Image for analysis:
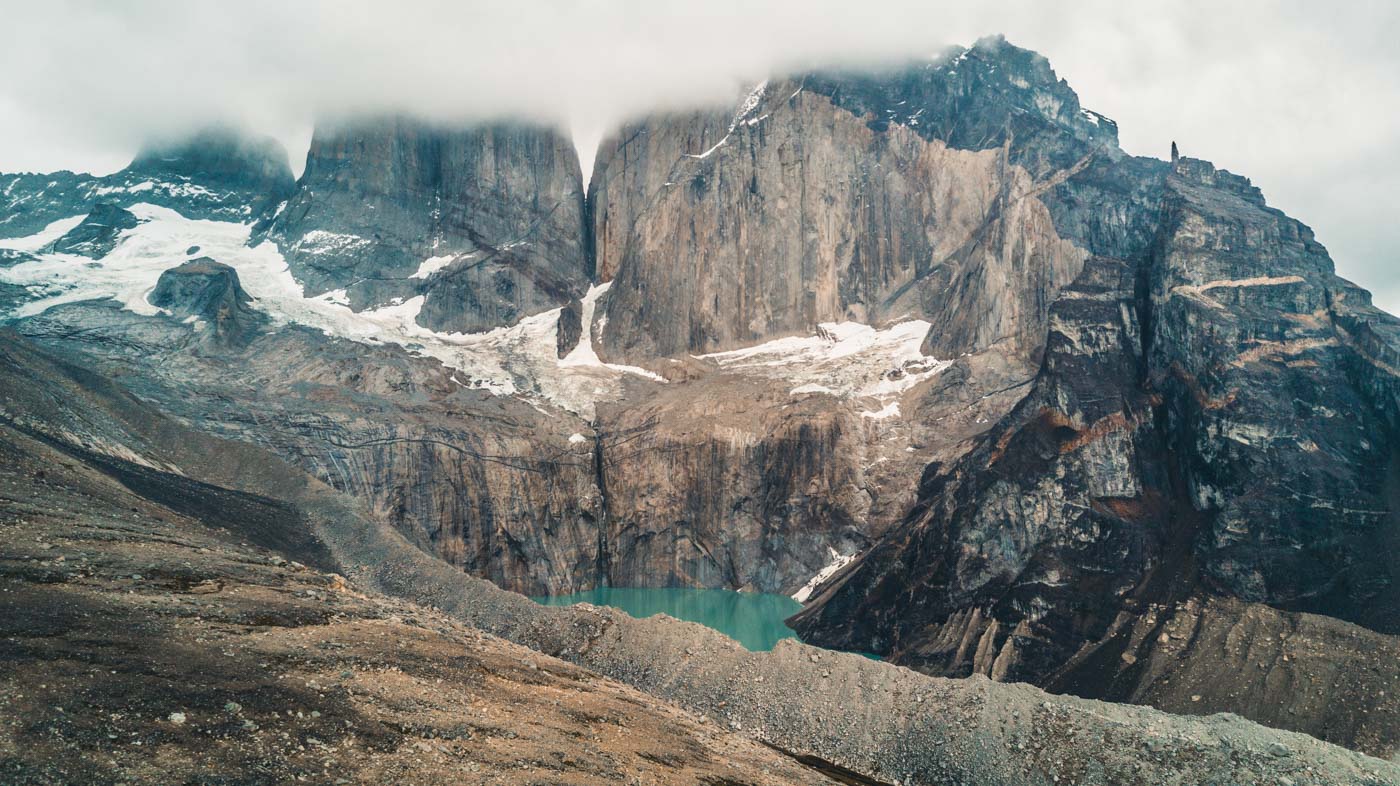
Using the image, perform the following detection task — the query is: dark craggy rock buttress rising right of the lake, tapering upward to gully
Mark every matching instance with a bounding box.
[795,258,1179,680]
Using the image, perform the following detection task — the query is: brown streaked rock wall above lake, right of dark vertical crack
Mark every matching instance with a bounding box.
[599,378,878,594]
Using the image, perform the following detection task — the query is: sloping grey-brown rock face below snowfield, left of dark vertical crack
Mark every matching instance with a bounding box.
[18,299,607,594]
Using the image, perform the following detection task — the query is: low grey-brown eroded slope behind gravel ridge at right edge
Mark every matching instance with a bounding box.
[1046,597,1400,758]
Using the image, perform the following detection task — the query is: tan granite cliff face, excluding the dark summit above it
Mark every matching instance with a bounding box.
[598,81,1084,360]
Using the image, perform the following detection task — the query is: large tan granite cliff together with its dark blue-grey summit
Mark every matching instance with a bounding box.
[591,39,1170,360]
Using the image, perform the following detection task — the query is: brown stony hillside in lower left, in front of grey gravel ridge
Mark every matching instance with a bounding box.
[0,389,836,786]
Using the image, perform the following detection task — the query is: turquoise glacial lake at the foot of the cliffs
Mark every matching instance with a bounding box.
[535,587,802,651]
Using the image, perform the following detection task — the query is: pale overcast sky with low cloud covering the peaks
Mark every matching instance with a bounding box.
[0,0,1400,312]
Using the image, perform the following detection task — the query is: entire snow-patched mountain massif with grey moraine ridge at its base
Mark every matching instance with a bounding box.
[0,30,1400,783]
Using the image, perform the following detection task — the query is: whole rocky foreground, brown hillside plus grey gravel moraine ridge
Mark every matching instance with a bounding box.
[0,335,1400,785]
